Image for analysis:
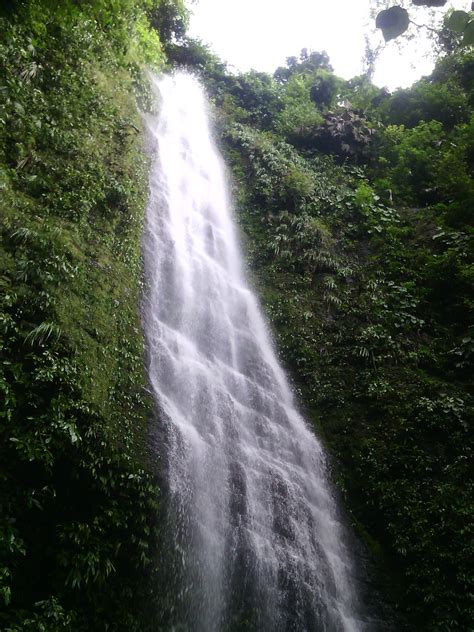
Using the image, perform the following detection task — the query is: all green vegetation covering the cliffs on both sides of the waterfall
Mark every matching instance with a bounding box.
[0,0,474,632]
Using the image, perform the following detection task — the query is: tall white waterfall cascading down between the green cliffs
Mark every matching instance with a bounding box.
[144,74,364,632]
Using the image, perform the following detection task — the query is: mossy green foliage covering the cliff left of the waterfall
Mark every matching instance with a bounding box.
[0,0,184,632]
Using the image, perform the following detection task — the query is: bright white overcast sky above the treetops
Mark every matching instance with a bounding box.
[188,0,471,89]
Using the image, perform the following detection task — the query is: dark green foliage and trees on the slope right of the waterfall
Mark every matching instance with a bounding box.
[172,42,474,630]
